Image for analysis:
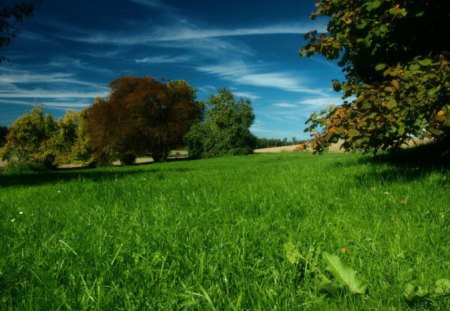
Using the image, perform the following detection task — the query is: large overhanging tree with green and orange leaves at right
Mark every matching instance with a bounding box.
[300,0,450,152]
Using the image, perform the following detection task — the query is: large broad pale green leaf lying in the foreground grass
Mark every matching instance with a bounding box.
[323,252,367,294]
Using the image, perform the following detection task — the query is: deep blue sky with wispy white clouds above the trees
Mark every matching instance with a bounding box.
[0,0,342,138]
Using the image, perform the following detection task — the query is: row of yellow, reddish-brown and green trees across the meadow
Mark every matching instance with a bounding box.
[0,76,257,169]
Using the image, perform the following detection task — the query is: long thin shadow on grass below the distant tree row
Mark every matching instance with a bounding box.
[0,163,191,188]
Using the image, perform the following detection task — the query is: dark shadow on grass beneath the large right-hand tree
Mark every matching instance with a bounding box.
[357,144,450,184]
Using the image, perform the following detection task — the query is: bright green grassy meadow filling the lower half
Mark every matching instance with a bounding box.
[0,154,450,310]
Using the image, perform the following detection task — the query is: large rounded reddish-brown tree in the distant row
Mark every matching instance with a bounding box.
[87,76,201,164]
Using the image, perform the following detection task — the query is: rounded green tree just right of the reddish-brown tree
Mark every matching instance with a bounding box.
[185,89,256,158]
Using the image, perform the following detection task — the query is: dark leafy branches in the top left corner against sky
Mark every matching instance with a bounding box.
[0,0,35,62]
